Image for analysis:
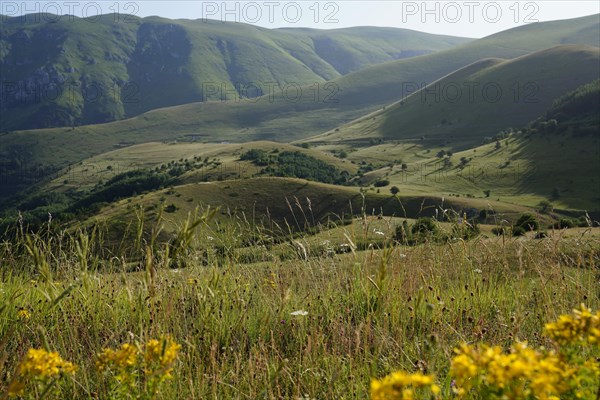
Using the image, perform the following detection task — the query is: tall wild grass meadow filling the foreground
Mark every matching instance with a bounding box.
[0,209,600,399]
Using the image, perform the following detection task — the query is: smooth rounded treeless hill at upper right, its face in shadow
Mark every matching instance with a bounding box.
[315,45,600,147]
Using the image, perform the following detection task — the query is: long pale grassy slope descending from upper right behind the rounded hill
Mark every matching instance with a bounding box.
[2,16,600,174]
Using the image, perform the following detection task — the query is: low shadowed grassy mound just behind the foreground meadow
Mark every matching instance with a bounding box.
[90,178,529,238]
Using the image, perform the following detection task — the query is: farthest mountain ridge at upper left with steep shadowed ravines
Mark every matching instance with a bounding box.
[0,14,469,131]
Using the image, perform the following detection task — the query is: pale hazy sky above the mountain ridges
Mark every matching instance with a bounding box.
[0,0,600,38]
